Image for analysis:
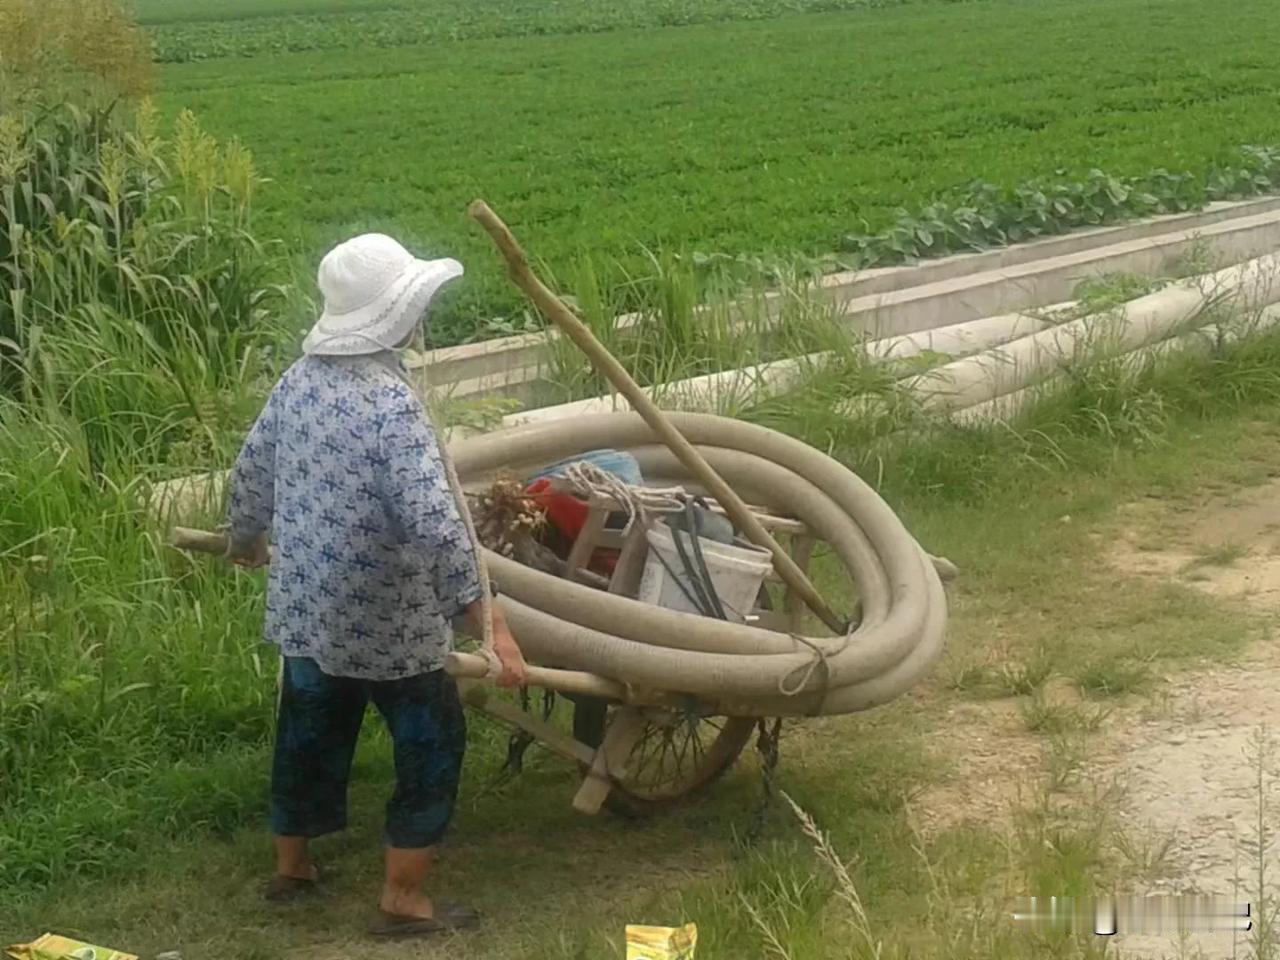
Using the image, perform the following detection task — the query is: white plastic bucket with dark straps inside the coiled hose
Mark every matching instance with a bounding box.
[637,525,773,623]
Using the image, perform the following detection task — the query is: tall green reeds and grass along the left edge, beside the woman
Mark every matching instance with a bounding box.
[0,101,293,887]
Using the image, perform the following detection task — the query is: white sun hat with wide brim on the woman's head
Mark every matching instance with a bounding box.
[302,233,462,356]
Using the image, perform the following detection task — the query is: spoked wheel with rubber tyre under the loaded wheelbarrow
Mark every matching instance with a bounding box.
[573,699,756,818]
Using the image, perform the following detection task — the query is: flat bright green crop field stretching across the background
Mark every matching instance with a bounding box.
[152,0,1280,339]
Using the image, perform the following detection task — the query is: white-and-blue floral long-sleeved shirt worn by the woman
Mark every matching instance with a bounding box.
[229,355,481,680]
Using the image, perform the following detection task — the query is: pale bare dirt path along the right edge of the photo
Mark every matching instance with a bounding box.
[1107,481,1280,957]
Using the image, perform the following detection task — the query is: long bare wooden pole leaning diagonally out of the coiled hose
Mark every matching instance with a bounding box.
[467,200,849,634]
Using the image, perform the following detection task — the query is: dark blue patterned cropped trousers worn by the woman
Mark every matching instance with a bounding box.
[271,657,467,849]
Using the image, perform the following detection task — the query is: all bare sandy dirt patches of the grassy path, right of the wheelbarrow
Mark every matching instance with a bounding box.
[922,480,1280,960]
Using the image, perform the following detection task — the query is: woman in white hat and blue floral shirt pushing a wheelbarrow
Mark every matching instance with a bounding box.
[229,234,525,936]
